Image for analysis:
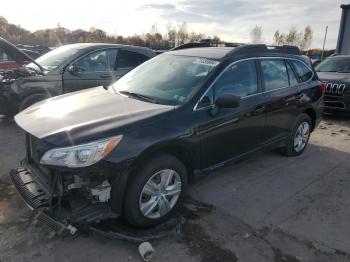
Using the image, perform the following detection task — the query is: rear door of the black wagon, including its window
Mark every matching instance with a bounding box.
[260,58,300,144]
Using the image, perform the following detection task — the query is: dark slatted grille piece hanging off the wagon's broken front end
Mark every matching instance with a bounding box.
[10,168,49,209]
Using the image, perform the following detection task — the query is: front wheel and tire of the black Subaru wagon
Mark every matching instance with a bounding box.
[123,154,188,228]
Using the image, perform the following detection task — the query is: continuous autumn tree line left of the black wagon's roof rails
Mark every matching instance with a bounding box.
[0,17,220,49]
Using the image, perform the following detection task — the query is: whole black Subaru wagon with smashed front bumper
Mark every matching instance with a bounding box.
[11,45,324,231]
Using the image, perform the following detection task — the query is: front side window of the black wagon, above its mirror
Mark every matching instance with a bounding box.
[213,60,258,97]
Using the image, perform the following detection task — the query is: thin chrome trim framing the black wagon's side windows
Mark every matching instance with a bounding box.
[193,56,315,111]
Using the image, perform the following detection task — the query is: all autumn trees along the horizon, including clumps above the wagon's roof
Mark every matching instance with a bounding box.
[0,16,313,50]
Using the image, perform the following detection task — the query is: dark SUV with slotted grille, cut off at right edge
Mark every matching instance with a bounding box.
[316,55,350,112]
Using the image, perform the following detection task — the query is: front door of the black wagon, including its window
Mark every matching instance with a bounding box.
[195,59,265,168]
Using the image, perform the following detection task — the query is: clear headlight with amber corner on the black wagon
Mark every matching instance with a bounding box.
[40,135,123,168]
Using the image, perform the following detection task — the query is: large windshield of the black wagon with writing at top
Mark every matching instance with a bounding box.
[112,54,219,105]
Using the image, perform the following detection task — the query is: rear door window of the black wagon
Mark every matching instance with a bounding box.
[260,59,289,91]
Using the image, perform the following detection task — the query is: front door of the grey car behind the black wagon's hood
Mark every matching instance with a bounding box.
[63,48,118,93]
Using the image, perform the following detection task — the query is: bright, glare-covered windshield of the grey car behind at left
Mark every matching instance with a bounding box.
[27,45,79,72]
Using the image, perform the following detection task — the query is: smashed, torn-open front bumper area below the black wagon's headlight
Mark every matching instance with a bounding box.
[10,165,118,234]
